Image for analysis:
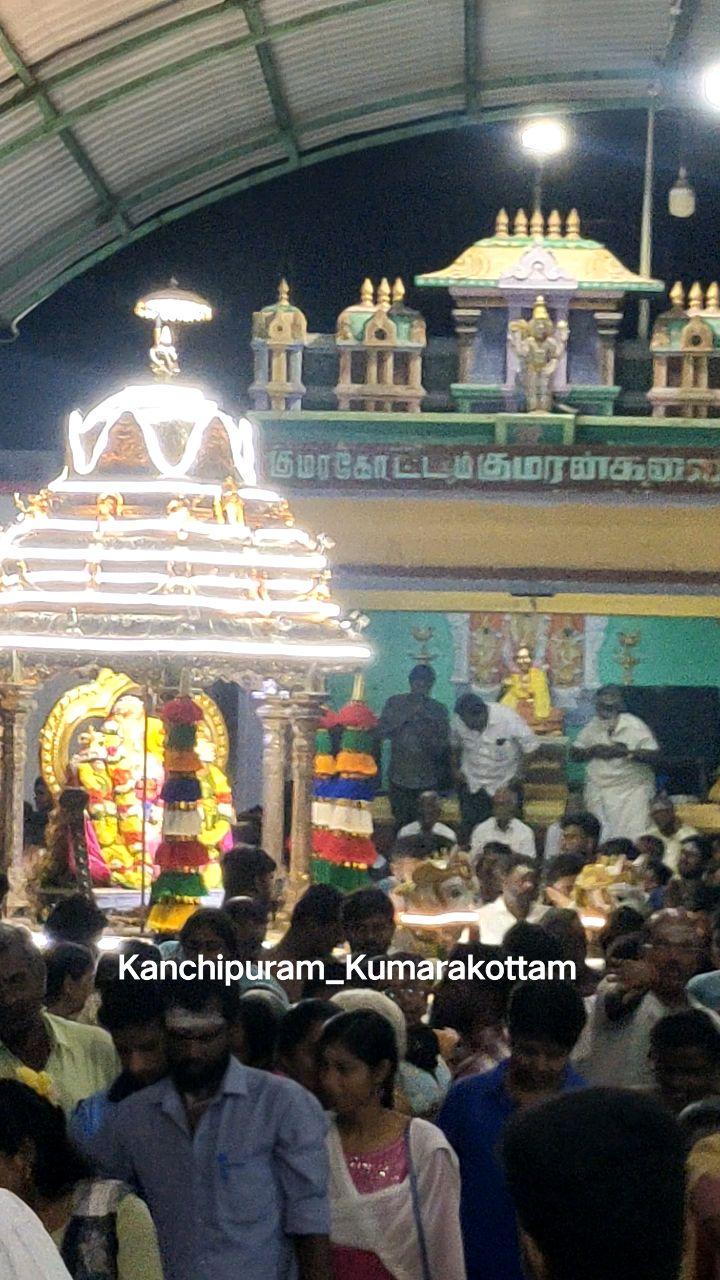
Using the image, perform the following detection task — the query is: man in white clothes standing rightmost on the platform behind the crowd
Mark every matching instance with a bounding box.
[570,685,660,841]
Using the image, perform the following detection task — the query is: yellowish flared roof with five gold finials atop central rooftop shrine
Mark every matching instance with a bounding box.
[415,209,665,296]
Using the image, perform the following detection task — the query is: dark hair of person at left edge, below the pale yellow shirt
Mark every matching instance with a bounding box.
[0,1080,90,1199]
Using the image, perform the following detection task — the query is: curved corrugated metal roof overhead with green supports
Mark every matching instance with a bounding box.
[0,0,707,323]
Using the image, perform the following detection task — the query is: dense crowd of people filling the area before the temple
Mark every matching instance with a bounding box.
[0,668,720,1280]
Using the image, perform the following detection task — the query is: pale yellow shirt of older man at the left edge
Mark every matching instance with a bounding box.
[0,1010,120,1115]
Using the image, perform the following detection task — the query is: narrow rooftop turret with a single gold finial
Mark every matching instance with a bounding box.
[250,279,307,413]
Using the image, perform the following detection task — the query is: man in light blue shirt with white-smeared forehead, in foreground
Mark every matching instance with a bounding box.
[95,982,331,1280]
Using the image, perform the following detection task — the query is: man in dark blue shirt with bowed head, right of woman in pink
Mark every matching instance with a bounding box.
[438,982,585,1280]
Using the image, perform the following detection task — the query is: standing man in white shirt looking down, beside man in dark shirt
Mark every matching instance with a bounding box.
[450,694,541,845]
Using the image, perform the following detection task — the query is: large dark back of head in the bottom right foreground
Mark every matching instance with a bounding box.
[502,1089,685,1280]
